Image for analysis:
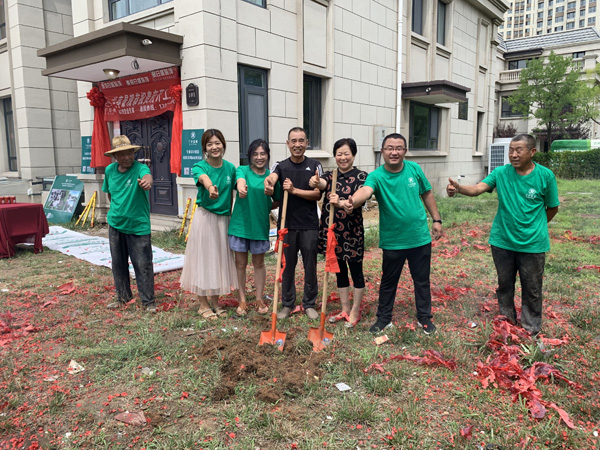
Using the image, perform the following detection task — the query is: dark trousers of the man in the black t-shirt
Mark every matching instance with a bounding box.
[281,230,319,309]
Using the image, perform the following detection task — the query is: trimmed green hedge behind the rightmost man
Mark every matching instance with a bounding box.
[533,149,600,179]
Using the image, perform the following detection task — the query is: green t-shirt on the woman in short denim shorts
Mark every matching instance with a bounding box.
[229,166,279,241]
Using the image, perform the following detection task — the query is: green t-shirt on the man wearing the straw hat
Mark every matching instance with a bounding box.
[102,161,150,236]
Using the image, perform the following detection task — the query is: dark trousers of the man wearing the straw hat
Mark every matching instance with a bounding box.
[108,226,154,306]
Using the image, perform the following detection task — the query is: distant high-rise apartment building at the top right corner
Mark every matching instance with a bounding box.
[499,0,600,41]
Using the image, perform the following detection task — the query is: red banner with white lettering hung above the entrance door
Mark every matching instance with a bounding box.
[98,66,180,121]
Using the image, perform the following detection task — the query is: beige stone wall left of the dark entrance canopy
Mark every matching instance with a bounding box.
[0,0,81,181]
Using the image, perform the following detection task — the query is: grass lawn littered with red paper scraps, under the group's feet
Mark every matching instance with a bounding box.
[0,180,600,449]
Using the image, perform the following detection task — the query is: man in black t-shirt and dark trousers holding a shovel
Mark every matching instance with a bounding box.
[265,127,323,320]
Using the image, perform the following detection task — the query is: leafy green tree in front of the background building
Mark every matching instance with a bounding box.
[508,52,598,147]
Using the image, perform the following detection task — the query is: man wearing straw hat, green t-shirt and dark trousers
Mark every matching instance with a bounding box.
[102,136,156,313]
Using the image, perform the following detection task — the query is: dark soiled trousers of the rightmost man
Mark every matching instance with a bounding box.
[492,245,546,334]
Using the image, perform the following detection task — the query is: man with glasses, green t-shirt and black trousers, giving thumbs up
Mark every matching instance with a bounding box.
[344,133,442,334]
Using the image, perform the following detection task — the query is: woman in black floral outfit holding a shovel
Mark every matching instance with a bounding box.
[309,138,367,328]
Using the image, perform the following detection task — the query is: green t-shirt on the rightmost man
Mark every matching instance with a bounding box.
[483,164,560,253]
